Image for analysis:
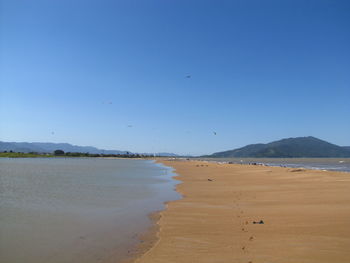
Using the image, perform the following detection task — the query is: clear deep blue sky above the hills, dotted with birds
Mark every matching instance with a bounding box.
[0,0,350,154]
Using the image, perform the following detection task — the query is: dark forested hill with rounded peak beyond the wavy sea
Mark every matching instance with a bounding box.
[207,136,350,158]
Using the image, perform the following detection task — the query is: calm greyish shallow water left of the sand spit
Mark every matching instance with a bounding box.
[0,158,179,263]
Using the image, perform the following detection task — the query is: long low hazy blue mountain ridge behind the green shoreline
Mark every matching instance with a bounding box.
[0,141,127,154]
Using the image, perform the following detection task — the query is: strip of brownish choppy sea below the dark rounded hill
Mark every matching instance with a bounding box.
[197,158,350,172]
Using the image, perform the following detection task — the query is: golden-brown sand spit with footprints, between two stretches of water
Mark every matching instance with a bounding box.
[136,161,350,263]
